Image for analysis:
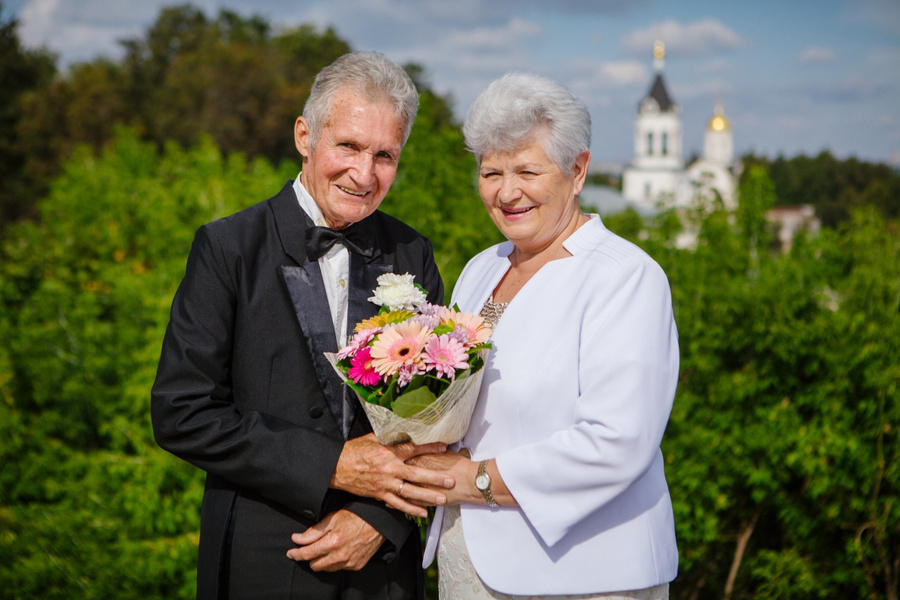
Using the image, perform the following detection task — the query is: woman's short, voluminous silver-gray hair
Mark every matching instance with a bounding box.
[463,73,591,174]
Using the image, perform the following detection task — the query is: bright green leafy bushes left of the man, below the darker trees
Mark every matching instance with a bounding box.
[0,131,293,598]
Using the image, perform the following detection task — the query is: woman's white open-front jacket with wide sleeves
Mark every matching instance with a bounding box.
[425,215,679,595]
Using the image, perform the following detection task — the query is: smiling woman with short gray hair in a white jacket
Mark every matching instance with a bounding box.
[414,74,678,600]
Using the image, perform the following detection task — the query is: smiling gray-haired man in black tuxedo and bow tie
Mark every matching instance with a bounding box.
[152,52,454,599]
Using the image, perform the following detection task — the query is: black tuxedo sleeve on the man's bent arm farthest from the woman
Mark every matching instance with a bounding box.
[151,226,343,520]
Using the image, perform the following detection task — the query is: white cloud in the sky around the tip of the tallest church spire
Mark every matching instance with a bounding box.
[620,18,744,56]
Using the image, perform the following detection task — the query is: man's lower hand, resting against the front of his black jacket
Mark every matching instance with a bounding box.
[287,510,384,571]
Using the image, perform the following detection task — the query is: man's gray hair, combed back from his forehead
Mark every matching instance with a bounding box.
[303,51,419,148]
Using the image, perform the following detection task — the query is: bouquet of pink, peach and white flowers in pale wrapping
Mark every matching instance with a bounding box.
[326,273,491,444]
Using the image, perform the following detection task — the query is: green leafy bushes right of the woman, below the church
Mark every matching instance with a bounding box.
[608,168,900,600]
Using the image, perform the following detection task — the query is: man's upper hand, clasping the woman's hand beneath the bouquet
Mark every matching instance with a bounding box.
[331,433,455,517]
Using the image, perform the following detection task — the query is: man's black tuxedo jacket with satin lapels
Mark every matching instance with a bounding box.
[152,182,444,598]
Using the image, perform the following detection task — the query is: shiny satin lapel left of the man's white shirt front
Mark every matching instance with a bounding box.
[281,261,350,438]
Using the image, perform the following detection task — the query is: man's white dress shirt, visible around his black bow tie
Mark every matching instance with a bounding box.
[294,174,355,348]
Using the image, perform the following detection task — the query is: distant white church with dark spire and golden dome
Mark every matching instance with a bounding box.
[622,41,740,211]
